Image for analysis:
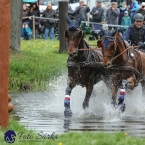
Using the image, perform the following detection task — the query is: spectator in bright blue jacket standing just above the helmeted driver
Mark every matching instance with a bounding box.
[129,0,139,23]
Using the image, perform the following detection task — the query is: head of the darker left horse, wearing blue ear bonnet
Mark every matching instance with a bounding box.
[65,16,83,56]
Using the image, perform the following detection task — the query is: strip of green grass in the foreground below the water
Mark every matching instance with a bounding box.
[0,119,145,145]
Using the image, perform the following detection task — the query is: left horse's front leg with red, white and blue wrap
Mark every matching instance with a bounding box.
[64,78,75,117]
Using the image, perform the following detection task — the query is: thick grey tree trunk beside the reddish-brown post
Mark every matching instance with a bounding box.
[10,0,23,51]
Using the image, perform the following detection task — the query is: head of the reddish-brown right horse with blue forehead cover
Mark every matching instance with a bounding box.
[97,29,117,67]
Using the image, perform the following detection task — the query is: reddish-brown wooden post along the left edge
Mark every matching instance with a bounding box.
[0,0,10,127]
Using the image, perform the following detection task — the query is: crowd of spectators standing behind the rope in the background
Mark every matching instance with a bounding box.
[22,0,145,40]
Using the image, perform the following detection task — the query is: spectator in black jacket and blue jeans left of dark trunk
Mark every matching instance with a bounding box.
[42,4,56,40]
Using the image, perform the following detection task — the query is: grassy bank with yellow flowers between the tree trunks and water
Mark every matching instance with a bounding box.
[9,39,68,93]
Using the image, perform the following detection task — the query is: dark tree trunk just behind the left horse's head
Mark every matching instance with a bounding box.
[59,1,68,53]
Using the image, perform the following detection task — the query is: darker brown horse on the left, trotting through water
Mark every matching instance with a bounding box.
[64,17,109,117]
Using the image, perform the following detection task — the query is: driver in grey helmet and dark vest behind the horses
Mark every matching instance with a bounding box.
[123,13,145,52]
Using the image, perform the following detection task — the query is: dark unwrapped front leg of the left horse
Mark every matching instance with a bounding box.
[83,84,93,109]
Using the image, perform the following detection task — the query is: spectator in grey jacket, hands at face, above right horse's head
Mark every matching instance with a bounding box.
[106,2,120,30]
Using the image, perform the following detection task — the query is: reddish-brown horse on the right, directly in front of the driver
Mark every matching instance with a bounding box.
[97,33,145,110]
